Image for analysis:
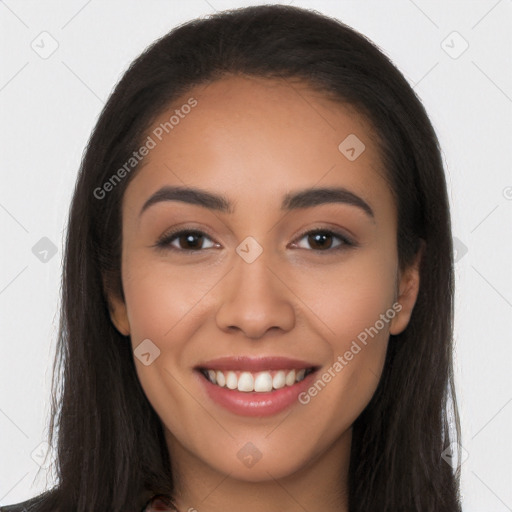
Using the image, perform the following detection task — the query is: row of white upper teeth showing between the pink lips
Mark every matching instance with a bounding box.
[205,368,306,393]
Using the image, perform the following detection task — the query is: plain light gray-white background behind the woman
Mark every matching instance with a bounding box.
[0,0,512,512]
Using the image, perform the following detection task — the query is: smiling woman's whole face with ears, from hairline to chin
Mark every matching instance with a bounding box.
[107,77,418,481]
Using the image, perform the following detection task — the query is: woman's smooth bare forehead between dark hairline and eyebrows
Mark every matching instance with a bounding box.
[125,76,392,220]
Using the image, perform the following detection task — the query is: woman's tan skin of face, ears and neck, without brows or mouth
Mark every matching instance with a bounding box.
[110,76,419,512]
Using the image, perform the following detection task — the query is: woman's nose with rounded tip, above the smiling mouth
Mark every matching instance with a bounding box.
[216,251,295,339]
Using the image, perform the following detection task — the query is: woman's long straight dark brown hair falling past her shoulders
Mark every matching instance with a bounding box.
[36,5,460,512]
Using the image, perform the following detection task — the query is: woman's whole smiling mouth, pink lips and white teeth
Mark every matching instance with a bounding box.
[194,357,320,417]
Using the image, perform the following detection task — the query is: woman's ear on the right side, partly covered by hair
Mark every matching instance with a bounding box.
[389,240,426,334]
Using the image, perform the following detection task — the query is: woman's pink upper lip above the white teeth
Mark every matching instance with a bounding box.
[196,356,317,372]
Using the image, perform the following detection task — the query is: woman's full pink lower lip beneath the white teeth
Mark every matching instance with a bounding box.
[197,372,316,416]
